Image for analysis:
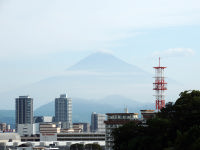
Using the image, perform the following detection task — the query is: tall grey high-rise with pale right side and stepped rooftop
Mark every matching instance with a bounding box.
[55,94,73,129]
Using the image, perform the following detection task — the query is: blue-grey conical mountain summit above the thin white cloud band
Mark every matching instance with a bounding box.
[67,51,143,72]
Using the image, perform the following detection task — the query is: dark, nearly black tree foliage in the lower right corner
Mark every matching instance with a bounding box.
[113,90,200,150]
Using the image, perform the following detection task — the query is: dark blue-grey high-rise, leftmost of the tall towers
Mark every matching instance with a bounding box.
[15,96,33,129]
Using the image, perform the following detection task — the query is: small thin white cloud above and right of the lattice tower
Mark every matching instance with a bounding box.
[153,48,195,58]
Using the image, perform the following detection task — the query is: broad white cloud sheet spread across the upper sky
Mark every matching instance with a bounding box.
[0,0,200,58]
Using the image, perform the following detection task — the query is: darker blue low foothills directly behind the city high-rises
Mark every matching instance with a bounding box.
[34,95,154,122]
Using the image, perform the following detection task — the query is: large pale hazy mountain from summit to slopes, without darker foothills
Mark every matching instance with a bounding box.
[0,52,177,109]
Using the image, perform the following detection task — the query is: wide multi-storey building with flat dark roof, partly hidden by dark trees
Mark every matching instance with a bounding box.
[105,113,138,150]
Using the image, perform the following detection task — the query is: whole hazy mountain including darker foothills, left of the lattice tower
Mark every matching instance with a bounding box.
[0,52,181,123]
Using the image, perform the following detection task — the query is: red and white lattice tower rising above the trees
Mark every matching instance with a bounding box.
[153,57,167,111]
